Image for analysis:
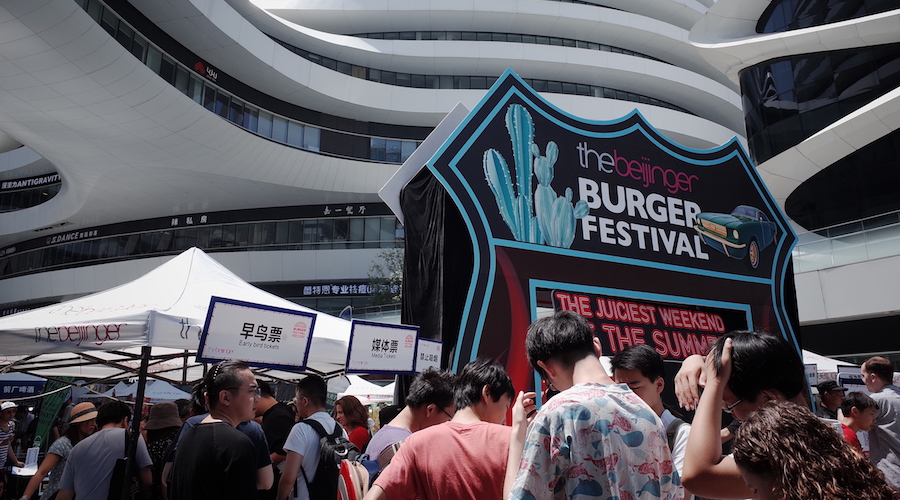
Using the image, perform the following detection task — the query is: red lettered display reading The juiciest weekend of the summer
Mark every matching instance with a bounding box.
[552,290,750,360]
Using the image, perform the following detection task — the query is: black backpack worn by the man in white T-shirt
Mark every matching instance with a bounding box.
[300,419,360,500]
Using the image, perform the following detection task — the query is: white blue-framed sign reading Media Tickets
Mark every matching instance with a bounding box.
[345,319,419,374]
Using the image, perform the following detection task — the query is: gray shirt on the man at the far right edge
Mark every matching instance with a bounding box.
[869,385,900,490]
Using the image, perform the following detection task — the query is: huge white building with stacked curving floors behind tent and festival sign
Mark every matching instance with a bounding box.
[0,0,743,322]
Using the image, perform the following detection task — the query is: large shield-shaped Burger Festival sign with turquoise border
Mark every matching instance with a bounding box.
[400,70,799,392]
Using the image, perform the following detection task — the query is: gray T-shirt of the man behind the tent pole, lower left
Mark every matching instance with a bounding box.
[59,427,153,500]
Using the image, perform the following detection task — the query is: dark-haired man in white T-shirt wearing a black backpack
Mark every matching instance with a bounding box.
[276,375,350,500]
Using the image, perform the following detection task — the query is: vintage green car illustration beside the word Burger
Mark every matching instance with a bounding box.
[694,205,778,269]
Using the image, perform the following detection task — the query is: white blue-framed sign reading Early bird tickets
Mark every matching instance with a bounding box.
[197,297,316,370]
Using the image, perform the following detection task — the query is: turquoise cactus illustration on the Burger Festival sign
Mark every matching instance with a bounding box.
[483,104,588,248]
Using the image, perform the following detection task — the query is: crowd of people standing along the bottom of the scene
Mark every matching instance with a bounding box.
[0,311,900,500]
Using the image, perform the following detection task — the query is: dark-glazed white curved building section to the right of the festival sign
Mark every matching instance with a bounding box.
[690,0,900,362]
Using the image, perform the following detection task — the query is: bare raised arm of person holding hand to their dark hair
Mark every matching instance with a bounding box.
[679,339,753,498]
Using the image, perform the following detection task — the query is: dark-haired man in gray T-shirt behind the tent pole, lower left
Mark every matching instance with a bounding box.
[56,401,153,500]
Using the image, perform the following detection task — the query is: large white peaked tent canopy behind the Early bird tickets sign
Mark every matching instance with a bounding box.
[0,248,350,383]
